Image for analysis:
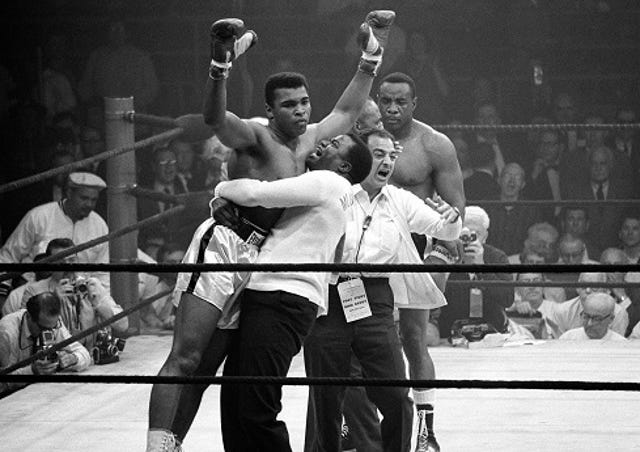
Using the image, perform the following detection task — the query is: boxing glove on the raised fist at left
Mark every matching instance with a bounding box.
[209,19,258,80]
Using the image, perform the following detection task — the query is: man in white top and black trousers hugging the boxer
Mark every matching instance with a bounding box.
[216,134,371,451]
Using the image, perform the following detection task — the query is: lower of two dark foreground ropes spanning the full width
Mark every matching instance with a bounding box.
[0,374,640,392]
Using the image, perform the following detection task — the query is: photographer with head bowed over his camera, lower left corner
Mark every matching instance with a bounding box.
[0,292,91,396]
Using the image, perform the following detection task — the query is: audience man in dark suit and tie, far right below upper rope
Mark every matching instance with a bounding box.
[567,146,633,256]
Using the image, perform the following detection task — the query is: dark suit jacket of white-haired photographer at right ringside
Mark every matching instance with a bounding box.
[439,244,513,338]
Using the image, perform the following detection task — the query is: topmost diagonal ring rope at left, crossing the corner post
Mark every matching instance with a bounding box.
[0,127,184,194]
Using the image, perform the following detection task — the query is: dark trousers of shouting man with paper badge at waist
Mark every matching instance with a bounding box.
[304,278,413,452]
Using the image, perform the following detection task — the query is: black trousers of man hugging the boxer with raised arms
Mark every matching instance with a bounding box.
[220,289,318,452]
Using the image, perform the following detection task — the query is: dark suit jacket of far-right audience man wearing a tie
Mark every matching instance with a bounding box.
[567,177,632,254]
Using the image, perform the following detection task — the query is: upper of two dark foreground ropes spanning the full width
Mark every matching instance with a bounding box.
[0,260,640,274]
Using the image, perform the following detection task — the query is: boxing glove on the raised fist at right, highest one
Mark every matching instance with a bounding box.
[356,10,396,76]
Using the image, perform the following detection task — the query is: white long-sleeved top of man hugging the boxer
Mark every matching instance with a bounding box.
[216,170,353,315]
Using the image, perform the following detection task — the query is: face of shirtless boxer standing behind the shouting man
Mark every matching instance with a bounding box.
[378,82,416,133]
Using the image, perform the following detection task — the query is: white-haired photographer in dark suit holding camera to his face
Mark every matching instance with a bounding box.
[439,206,513,338]
